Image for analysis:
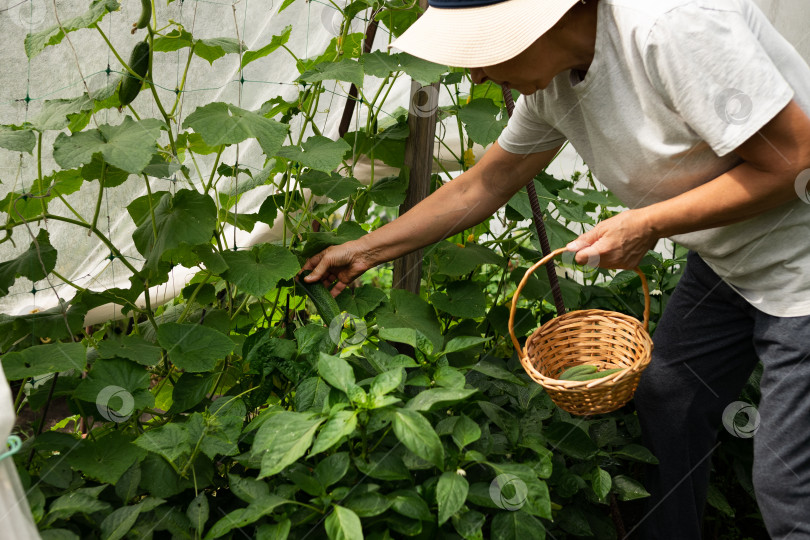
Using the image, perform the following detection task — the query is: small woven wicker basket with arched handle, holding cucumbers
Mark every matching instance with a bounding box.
[509,248,653,415]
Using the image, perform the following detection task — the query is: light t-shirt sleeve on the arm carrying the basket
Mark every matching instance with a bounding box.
[642,2,794,157]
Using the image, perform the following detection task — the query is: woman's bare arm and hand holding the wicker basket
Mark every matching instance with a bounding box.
[568,101,810,268]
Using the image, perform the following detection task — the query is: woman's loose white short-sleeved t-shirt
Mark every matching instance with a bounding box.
[498,0,810,316]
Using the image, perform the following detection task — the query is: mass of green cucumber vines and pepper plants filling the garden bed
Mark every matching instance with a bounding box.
[0,0,756,540]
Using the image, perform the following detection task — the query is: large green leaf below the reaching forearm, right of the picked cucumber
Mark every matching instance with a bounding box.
[376,289,443,351]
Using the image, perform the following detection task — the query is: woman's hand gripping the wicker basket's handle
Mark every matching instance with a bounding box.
[566,209,658,269]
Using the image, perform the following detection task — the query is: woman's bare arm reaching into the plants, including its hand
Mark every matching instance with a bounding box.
[302,142,559,296]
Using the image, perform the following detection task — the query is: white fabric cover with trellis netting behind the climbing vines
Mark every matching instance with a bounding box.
[0,0,810,325]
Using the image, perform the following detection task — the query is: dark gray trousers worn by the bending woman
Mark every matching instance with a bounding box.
[633,252,810,540]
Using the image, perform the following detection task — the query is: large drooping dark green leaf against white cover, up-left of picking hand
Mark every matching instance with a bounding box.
[127,189,217,269]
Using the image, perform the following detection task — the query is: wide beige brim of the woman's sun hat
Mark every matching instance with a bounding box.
[390,0,580,67]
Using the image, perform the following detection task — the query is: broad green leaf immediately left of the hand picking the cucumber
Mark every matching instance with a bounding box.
[222,244,301,298]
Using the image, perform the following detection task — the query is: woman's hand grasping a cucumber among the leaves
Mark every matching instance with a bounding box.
[299,240,375,296]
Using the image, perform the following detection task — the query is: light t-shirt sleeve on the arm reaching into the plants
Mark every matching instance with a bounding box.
[498,94,567,154]
